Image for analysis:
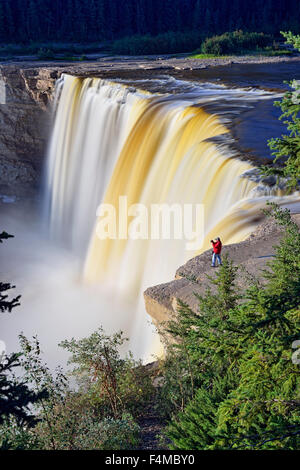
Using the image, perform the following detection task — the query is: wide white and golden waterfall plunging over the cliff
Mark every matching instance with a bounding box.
[46,75,298,359]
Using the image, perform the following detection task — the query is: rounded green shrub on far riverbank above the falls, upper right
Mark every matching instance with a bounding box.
[201,31,272,55]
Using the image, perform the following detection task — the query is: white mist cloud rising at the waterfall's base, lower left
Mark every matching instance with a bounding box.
[0,205,161,369]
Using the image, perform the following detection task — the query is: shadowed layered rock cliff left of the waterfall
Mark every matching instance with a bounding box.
[0,66,58,197]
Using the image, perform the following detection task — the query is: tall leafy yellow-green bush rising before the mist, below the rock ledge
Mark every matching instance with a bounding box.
[60,328,154,419]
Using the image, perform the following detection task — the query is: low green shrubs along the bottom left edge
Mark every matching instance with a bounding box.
[0,395,140,450]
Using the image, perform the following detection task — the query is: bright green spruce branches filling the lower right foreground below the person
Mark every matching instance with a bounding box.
[165,206,300,449]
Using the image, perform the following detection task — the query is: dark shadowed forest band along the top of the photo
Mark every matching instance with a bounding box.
[0,0,300,43]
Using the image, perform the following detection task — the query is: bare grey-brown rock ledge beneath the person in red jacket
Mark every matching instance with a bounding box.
[144,214,300,326]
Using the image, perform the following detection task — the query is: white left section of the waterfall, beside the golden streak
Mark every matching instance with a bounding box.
[46,75,148,252]
